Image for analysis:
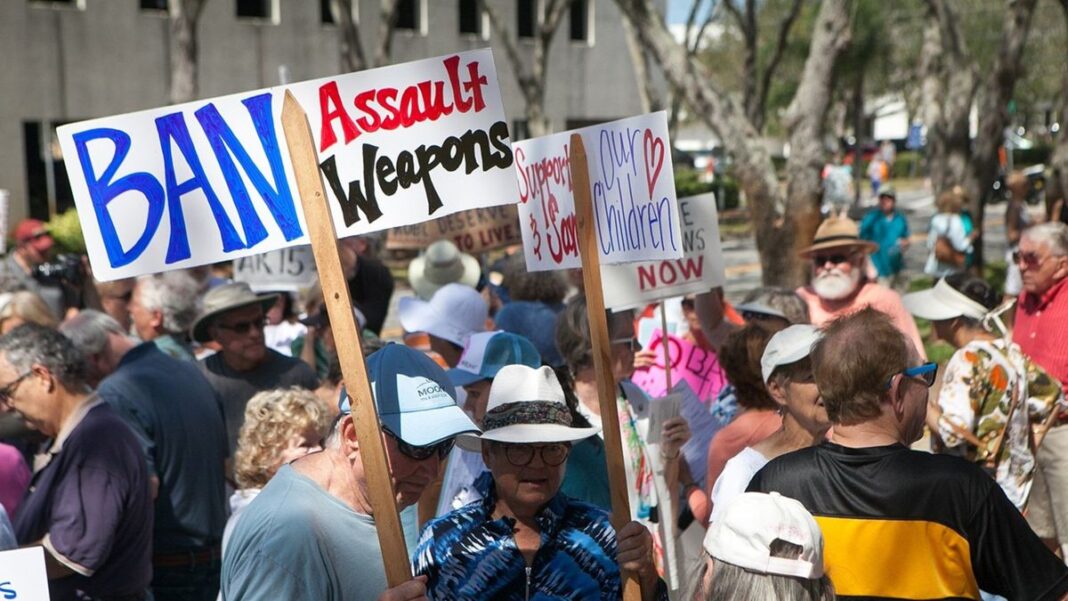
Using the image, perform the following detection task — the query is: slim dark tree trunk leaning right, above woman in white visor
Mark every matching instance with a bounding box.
[963,0,1037,266]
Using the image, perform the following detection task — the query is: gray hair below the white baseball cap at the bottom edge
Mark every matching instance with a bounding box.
[694,557,835,601]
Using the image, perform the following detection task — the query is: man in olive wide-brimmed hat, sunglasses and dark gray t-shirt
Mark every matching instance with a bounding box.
[192,282,319,455]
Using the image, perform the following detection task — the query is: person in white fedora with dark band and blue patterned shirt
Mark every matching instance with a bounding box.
[414,365,668,600]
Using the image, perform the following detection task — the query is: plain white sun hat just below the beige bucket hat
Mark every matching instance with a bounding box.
[397,284,489,346]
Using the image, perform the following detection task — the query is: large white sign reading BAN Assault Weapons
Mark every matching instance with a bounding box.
[59,49,516,281]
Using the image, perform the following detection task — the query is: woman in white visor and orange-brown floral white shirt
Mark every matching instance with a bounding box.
[902,273,1064,510]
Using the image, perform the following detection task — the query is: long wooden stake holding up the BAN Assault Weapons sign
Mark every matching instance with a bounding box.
[282,91,411,588]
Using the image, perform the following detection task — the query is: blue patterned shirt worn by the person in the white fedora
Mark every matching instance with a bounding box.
[413,472,663,601]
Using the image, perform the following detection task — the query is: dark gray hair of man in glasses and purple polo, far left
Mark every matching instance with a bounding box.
[0,318,88,392]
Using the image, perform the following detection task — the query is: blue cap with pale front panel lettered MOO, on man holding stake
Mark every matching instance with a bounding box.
[337,344,480,446]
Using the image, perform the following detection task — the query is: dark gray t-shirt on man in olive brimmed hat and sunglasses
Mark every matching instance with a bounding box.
[198,349,319,457]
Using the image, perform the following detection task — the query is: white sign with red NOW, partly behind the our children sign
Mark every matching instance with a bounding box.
[601,194,725,310]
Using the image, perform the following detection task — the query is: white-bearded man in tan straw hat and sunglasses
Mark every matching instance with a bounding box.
[797,217,924,354]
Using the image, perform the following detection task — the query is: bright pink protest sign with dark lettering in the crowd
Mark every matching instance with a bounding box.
[630,331,726,404]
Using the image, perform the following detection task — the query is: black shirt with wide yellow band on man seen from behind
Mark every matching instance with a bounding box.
[749,443,1068,601]
